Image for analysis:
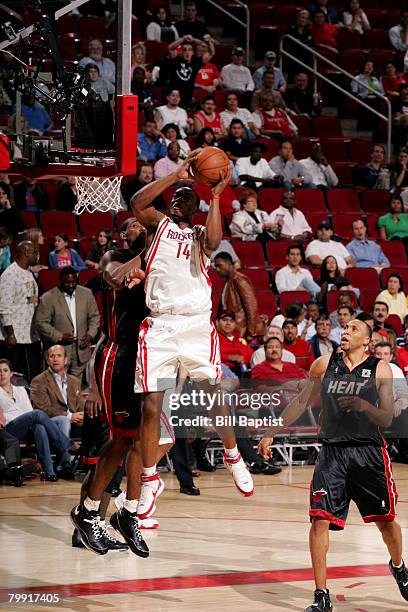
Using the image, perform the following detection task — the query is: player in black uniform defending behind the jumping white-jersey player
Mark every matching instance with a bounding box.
[71,217,171,557]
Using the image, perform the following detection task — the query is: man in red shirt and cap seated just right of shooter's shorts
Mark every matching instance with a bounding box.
[217,311,253,376]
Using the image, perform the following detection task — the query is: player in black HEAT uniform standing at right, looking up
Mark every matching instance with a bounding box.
[259,320,408,612]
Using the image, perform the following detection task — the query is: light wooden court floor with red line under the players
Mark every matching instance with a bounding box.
[0,465,408,612]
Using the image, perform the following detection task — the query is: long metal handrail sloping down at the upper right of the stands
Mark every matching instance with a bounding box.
[279,34,392,163]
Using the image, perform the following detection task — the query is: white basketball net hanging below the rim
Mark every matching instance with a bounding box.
[74,176,123,215]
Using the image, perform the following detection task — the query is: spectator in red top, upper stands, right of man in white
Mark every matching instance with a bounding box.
[252,94,298,142]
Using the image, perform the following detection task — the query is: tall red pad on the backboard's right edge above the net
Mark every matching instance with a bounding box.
[115,95,138,175]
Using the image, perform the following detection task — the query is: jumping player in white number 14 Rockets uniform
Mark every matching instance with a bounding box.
[131,150,253,518]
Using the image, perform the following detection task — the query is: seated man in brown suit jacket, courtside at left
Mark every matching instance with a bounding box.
[30,344,84,438]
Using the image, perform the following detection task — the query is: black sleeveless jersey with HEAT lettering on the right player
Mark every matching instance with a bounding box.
[320,353,384,445]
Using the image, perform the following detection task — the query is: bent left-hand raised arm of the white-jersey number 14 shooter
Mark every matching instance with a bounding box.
[130,149,201,230]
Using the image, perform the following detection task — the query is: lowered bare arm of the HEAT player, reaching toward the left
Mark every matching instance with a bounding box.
[258,355,330,459]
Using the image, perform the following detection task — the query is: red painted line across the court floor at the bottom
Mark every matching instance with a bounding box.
[0,565,390,603]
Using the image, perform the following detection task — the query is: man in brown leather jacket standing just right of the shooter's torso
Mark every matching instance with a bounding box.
[214,253,265,340]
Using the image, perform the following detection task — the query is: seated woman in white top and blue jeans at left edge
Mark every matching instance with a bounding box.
[0,359,74,482]
